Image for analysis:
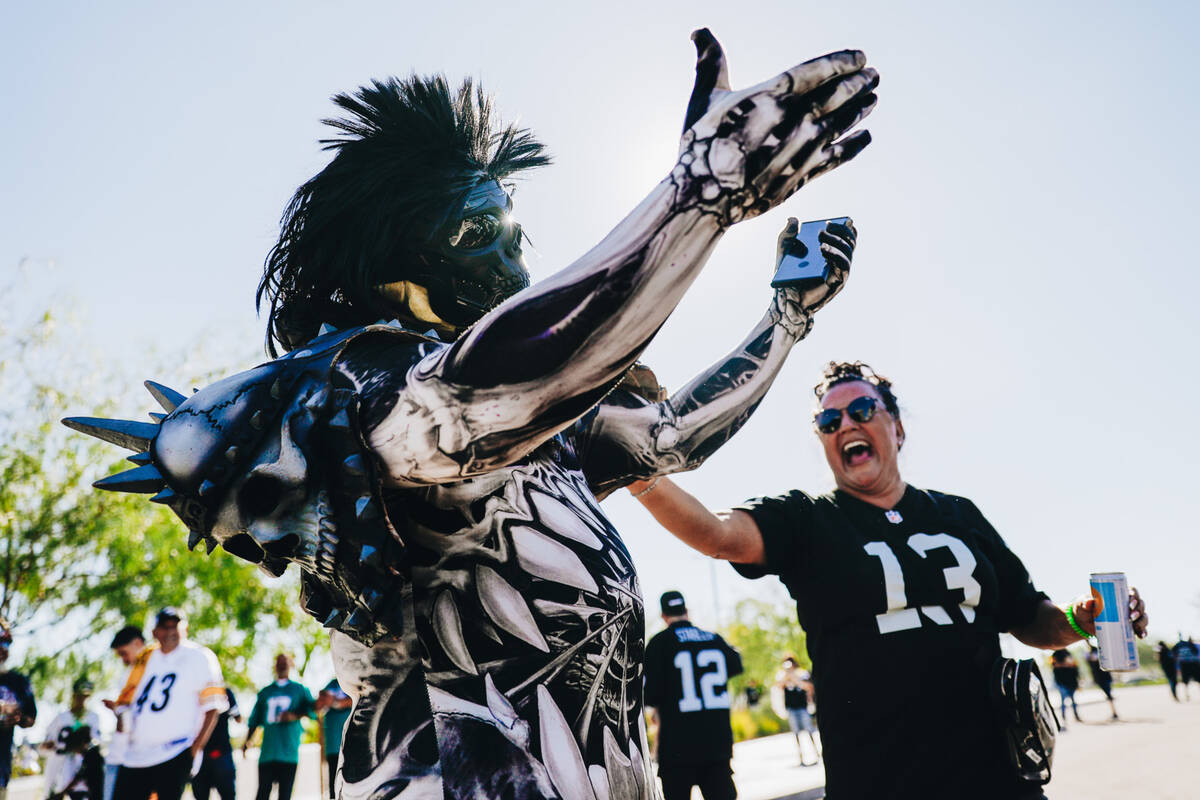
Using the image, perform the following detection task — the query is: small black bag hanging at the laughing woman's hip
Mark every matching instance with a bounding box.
[990,658,1062,786]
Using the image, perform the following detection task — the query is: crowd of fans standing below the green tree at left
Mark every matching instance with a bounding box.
[0,607,352,800]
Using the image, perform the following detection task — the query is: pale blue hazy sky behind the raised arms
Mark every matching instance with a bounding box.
[0,2,1200,690]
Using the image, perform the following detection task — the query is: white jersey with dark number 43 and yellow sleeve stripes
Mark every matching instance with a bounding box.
[122,642,228,768]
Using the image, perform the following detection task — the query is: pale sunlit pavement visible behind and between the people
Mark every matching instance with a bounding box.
[8,685,1200,800]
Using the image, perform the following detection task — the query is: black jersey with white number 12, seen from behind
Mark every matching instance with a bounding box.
[646,621,742,766]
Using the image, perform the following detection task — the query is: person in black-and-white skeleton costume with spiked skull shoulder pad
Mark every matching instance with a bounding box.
[67,30,878,800]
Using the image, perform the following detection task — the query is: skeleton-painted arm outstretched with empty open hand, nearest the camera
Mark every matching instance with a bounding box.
[352,30,878,486]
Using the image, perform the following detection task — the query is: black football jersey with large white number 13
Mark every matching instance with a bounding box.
[734,486,1045,800]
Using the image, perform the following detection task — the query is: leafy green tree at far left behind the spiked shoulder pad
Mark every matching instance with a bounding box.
[0,302,328,698]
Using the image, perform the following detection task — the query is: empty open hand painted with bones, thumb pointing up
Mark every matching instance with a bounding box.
[671,29,880,225]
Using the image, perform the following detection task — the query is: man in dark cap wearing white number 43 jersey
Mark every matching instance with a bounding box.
[115,606,228,800]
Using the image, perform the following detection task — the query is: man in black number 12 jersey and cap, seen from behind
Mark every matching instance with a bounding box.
[646,591,742,800]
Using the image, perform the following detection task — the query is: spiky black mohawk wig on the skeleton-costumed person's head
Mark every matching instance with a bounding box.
[256,74,550,356]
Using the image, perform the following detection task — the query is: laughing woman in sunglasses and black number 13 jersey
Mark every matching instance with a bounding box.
[629,362,1147,800]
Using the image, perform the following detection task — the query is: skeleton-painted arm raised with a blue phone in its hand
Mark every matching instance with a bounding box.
[582,218,857,497]
